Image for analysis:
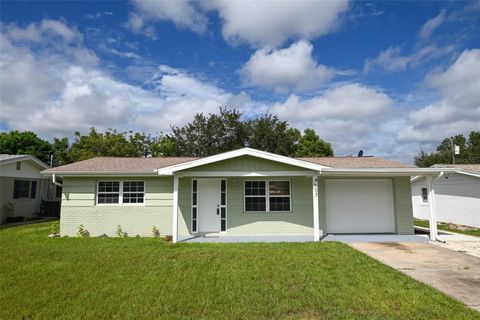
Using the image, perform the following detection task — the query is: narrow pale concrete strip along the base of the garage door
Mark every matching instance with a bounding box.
[322,234,428,243]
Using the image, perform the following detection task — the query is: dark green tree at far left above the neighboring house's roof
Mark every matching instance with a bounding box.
[0,130,52,163]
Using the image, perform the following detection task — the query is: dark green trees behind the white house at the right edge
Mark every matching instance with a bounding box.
[414,131,480,167]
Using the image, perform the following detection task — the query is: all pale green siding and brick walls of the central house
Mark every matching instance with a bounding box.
[60,160,413,237]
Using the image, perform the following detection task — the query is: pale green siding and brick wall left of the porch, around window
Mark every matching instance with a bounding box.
[60,177,173,236]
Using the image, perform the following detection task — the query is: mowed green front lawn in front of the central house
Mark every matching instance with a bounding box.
[0,223,479,319]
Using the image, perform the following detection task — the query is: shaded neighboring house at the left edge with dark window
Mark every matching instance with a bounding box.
[0,154,56,224]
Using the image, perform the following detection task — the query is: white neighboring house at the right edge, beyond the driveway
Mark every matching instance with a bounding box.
[412,164,480,228]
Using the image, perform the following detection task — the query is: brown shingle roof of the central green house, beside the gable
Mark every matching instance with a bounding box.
[43,157,409,174]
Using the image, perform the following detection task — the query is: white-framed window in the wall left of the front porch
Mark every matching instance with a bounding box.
[97,181,145,205]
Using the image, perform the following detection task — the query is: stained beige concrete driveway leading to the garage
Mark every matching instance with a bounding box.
[350,242,480,311]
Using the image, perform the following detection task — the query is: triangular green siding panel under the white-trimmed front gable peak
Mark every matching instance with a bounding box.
[188,156,314,172]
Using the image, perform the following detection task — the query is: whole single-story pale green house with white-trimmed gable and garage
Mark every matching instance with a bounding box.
[43,148,446,242]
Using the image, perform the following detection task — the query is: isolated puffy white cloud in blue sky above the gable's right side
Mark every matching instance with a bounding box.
[240,40,335,92]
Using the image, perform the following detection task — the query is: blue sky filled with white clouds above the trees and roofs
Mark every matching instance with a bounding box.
[0,0,480,162]
